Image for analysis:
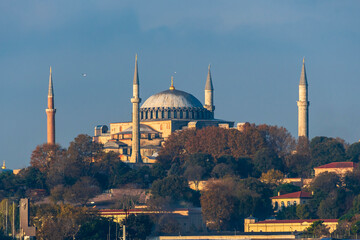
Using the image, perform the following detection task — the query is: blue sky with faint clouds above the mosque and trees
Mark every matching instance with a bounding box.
[0,0,360,168]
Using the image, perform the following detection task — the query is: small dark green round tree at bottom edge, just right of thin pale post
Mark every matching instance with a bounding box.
[122,214,154,240]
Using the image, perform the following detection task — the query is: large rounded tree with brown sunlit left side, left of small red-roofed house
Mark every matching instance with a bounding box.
[200,177,272,230]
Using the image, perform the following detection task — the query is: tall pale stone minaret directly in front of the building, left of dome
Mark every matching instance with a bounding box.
[130,55,141,163]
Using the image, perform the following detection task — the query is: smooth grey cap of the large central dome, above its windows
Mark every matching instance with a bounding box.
[141,89,203,108]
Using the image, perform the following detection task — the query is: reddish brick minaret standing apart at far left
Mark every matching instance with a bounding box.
[46,67,56,144]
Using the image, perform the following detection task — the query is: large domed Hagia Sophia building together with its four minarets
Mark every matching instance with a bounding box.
[46,56,310,163]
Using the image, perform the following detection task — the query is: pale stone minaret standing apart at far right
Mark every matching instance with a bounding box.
[297,58,310,138]
